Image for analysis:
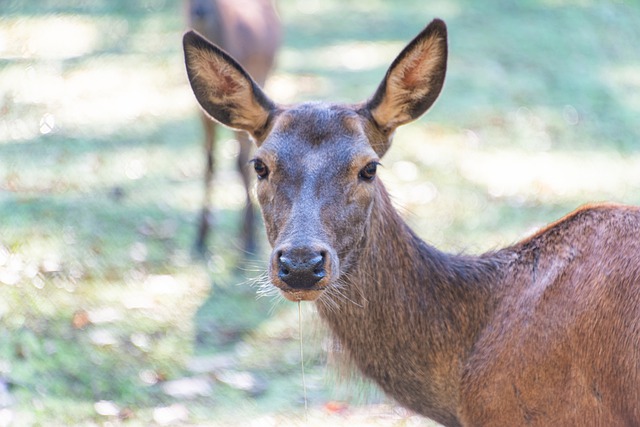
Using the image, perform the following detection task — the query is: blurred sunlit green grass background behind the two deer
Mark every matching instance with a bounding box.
[0,0,640,426]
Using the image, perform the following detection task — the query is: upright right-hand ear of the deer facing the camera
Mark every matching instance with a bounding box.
[365,19,447,133]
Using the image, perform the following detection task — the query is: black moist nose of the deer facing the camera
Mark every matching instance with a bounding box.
[278,251,326,289]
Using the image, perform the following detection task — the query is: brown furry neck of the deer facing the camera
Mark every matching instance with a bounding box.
[318,184,499,425]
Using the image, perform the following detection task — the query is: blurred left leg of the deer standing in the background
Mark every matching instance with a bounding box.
[196,114,216,254]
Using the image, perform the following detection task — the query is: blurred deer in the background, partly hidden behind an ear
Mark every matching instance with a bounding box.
[184,0,282,254]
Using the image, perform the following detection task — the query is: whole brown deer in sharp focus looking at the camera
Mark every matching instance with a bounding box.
[183,19,640,426]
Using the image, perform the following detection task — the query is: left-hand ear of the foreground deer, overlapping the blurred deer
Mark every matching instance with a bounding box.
[182,31,276,141]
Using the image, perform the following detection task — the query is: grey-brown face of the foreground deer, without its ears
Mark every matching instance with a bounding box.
[253,104,379,300]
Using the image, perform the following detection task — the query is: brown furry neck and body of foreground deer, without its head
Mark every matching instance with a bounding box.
[328,193,640,426]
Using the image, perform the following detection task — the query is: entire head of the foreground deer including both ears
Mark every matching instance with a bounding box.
[184,20,447,301]
